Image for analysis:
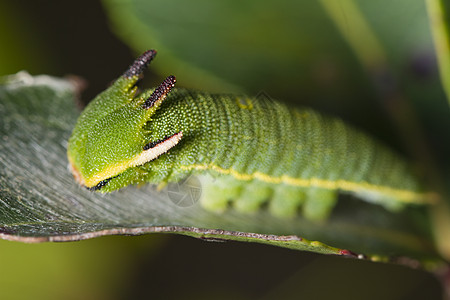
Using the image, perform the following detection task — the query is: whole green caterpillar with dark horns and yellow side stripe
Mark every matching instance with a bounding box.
[68,50,429,219]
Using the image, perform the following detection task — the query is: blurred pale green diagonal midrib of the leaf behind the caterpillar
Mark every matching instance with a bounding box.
[320,0,442,190]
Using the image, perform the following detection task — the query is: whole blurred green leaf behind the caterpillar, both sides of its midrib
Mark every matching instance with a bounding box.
[99,0,442,115]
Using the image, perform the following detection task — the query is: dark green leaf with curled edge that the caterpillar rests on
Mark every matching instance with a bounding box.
[0,73,439,267]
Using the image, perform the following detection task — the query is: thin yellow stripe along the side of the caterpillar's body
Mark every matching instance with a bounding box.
[181,164,436,204]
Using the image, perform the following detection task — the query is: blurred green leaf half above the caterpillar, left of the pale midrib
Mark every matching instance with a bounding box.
[104,0,367,107]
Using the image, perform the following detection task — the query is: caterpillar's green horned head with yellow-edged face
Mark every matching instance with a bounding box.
[67,50,183,191]
